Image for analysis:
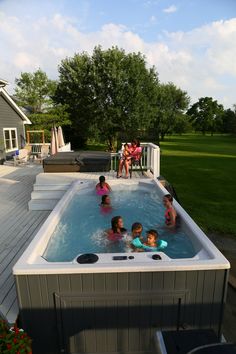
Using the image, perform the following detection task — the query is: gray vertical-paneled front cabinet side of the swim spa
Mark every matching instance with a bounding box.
[15,270,228,354]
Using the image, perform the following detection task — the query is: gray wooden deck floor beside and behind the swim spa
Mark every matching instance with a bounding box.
[0,164,148,324]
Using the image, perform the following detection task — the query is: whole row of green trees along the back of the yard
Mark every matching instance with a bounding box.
[15,46,236,150]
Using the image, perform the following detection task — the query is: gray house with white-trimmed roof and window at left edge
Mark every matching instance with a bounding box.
[0,79,32,156]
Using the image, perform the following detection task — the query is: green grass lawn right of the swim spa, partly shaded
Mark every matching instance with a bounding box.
[161,134,236,237]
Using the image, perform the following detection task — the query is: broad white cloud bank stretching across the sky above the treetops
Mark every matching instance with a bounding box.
[0,9,236,107]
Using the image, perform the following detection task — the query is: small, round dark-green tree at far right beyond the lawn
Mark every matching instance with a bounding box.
[187,97,224,134]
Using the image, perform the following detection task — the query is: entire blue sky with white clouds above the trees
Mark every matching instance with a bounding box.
[0,0,236,108]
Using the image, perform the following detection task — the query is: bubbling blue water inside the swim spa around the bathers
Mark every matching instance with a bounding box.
[43,186,196,262]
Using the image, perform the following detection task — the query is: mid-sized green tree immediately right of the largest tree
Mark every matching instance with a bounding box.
[153,82,190,142]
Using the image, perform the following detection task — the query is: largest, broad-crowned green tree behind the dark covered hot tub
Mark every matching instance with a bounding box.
[55,47,158,150]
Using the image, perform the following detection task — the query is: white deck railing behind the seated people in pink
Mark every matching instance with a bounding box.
[111,143,160,179]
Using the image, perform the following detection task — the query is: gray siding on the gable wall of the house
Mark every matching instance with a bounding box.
[0,94,25,153]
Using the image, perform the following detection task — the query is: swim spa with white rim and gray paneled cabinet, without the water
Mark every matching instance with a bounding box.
[14,180,229,353]
